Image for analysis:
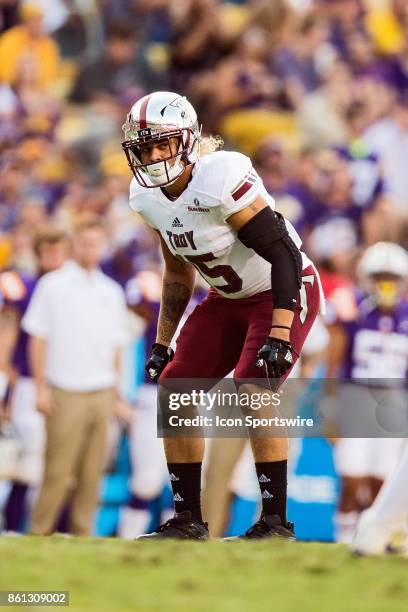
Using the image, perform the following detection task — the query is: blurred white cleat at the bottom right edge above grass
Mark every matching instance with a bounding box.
[351,509,408,555]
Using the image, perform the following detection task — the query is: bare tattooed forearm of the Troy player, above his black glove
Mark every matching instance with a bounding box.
[157,280,192,345]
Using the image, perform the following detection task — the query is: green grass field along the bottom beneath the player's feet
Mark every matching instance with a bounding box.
[0,536,408,612]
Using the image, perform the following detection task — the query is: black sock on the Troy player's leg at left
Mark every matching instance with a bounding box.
[167,462,202,521]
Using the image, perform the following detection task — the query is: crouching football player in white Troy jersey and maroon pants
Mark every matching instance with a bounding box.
[122,92,323,540]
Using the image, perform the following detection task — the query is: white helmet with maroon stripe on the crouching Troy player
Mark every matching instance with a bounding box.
[122,91,201,188]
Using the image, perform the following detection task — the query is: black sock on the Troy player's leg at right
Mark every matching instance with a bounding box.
[255,460,288,525]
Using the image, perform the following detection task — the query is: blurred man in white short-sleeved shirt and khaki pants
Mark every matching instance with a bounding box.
[22,220,127,535]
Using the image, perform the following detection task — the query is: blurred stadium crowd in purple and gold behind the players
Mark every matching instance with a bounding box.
[0,0,408,530]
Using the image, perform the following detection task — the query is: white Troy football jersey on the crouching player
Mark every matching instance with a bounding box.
[130,151,310,299]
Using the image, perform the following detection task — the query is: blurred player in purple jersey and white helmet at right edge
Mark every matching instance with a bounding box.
[335,242,408,541]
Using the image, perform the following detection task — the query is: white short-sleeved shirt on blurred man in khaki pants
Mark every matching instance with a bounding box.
[22,261,127,392]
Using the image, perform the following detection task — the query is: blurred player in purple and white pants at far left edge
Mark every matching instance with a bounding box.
[0,225,67,532]
